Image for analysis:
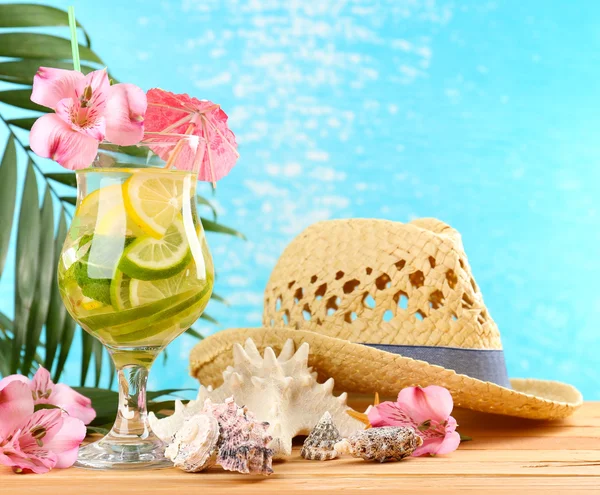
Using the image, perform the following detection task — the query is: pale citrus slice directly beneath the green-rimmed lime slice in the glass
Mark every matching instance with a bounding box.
[129,263,207,307]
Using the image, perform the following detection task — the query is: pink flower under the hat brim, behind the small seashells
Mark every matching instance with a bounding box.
[367,385,460,456]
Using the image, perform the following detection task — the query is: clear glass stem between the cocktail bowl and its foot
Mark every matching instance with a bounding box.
[111,364,150,440]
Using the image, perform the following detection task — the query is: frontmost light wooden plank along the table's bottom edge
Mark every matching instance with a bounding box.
[2,472,600,495]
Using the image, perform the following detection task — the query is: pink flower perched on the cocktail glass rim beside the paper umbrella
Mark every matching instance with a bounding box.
[29,67,147,170]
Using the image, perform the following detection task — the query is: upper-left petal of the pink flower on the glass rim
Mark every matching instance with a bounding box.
[31,67,85,108]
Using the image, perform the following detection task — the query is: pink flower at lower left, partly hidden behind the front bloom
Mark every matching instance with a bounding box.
[0,366,96,425]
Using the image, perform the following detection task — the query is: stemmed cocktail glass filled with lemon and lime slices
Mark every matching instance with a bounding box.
[58,138,214,469]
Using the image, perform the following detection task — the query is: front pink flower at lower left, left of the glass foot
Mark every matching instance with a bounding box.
[0,380,86,473]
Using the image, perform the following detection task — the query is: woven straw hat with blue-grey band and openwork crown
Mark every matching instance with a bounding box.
[190,218,582,419]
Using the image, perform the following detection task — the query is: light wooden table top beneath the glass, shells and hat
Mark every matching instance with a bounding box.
[0,402,600,495]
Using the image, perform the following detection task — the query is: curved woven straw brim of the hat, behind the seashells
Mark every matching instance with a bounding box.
[190,328,583,420]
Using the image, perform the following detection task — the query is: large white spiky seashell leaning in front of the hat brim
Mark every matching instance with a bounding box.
[150,339,364,458]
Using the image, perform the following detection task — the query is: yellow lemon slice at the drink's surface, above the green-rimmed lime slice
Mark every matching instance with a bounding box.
[123,172,185,239]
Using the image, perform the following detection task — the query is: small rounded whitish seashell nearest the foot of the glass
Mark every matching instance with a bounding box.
[165,414,219,473]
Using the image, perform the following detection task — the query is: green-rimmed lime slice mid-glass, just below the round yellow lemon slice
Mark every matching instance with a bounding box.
[119,217,192,280]
